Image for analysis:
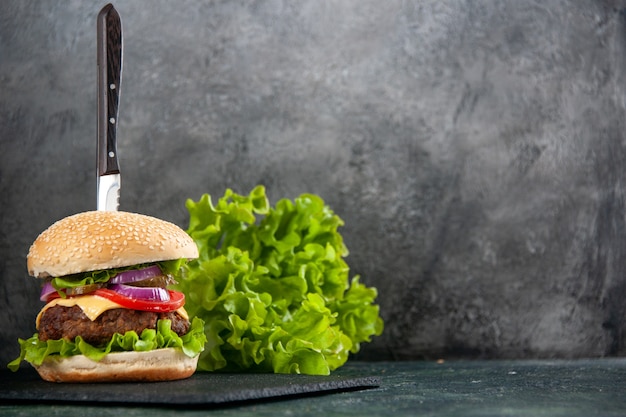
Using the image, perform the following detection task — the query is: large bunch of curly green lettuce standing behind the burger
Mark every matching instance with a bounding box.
[174,186,383,375]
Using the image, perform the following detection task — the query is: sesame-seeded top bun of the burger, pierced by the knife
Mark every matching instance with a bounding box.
[27,211,198,278]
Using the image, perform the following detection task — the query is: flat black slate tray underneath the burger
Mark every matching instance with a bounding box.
[0,368,379,406]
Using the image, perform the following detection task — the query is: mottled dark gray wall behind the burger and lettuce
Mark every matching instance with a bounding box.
[0,0,626,361]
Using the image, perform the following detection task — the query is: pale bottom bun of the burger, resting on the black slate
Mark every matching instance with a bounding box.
[35,348,199,382]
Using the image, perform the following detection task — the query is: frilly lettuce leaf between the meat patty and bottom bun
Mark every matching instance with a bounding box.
[8,317,206,371]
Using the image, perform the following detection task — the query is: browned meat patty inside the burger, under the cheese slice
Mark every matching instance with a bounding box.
[39,306,189,346]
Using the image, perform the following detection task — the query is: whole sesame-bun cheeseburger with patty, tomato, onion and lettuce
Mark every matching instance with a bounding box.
[9,211,206,382]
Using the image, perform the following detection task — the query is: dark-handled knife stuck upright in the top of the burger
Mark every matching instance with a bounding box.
[97,4,122,211]
